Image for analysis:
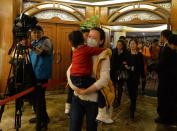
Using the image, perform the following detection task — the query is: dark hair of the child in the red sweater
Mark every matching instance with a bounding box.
[68,30,84,48]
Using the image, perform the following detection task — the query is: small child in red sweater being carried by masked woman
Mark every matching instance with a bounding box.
[66,31,106,118]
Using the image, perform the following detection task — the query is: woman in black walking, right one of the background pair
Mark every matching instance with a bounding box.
[125,39,145,119]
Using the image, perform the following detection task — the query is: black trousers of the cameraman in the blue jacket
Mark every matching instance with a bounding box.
[32,79,49,130]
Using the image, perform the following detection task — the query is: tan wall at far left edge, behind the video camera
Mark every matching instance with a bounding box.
[0,0,21,92]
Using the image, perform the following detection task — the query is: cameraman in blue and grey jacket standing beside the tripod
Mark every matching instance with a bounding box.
[30,25,53,131]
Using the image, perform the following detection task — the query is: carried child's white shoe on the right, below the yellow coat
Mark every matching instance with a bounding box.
[96,107,114,124]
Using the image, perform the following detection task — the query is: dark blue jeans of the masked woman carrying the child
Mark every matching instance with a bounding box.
[69,95,98,131]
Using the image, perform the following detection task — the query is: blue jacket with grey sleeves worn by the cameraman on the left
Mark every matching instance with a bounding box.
[30,37,53,79]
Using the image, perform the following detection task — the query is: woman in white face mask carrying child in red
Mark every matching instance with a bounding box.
[67,28,114,131]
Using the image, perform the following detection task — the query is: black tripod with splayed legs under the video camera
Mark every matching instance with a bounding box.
[1,42,35,131]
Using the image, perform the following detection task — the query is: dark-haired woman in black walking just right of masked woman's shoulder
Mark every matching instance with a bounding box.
[110,40,127,107]
